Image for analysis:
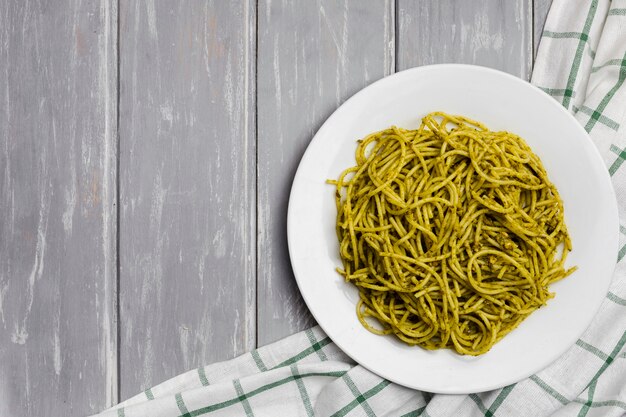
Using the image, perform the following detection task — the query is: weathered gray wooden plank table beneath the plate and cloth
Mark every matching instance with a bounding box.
[0,0,550,416]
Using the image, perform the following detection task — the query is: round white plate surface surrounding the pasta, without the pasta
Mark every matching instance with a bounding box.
[287,65,618,394]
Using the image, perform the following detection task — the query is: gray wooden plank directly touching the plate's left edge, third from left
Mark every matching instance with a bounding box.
[257,0,394,345]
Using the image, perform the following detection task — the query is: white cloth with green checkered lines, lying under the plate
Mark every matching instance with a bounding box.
[92,0,626,417]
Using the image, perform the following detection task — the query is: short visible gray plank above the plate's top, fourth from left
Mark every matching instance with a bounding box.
[397,0,533,79]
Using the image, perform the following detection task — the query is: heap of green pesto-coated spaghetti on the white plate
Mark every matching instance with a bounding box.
[328,112,575,355]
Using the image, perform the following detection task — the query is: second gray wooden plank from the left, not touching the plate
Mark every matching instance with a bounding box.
[120,0,256,398]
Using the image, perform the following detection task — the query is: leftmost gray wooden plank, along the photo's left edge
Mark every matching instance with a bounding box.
[0,0,117,416]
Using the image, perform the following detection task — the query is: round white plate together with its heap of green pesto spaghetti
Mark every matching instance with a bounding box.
[287,64,619,394]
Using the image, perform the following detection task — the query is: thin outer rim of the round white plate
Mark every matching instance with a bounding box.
[287,63,619,394]
